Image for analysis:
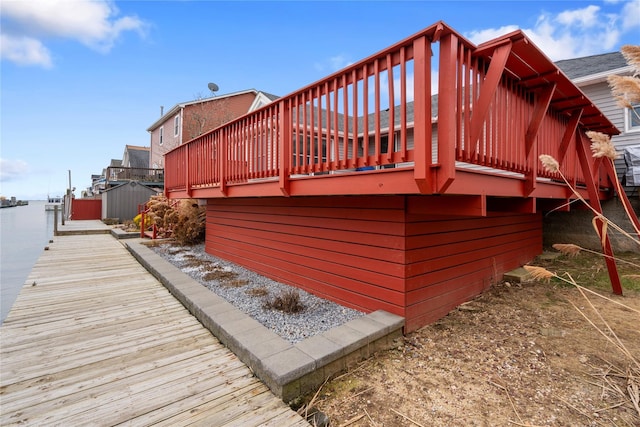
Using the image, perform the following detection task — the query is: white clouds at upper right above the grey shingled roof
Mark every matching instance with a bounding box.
[468,0,640,61]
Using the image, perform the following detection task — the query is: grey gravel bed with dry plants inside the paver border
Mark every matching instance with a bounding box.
[151,243,364,344]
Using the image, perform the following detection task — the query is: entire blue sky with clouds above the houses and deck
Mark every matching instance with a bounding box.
[0,0,640,200]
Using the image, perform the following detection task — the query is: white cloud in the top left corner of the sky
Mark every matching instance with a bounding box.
[0,0,147,66]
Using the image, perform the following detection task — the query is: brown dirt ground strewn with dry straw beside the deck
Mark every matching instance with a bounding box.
[308,253,640,427]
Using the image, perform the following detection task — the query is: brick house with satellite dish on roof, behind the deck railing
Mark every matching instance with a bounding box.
[147,89,278,169]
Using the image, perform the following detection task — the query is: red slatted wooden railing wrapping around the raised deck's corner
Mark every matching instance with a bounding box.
[165,23,616,195]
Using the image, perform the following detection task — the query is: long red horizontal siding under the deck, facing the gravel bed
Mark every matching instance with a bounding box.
[206,197,405,316]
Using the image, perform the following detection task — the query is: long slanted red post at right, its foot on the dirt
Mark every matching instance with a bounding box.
[576,135,622,295]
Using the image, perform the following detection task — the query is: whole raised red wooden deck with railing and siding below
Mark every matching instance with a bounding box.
[165,22,632,330]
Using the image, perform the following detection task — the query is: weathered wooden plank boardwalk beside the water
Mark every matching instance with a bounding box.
[0,235,309,426]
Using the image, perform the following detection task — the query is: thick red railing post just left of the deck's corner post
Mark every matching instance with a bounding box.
[413,36,432,194]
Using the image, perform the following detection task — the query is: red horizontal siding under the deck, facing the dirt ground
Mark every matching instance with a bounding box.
[405,214,542,330]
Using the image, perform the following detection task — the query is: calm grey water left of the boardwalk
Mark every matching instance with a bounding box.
[0,200,54,323]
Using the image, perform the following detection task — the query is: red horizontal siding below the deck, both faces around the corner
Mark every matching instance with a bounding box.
[206,196,542,332]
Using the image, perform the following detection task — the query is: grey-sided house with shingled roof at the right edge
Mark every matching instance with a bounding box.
[556,52,640,196]
